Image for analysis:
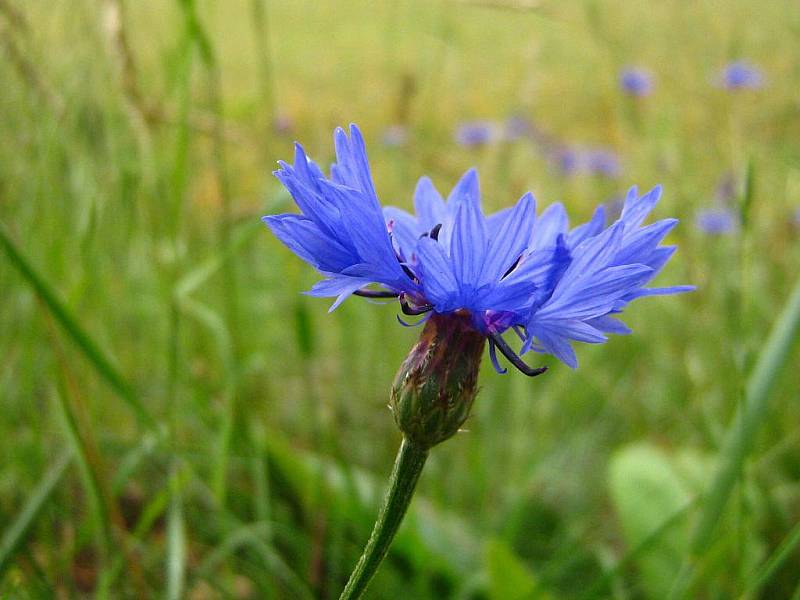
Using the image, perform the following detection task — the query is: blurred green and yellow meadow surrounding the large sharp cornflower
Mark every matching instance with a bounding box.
[0,0,800,600]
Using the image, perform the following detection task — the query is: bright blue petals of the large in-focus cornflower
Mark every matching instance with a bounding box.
[264,125,692,375]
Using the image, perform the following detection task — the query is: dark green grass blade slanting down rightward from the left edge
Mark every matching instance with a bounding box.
[0,223,156,430]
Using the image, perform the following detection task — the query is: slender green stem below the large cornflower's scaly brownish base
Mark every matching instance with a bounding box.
[339,438,428,600]
